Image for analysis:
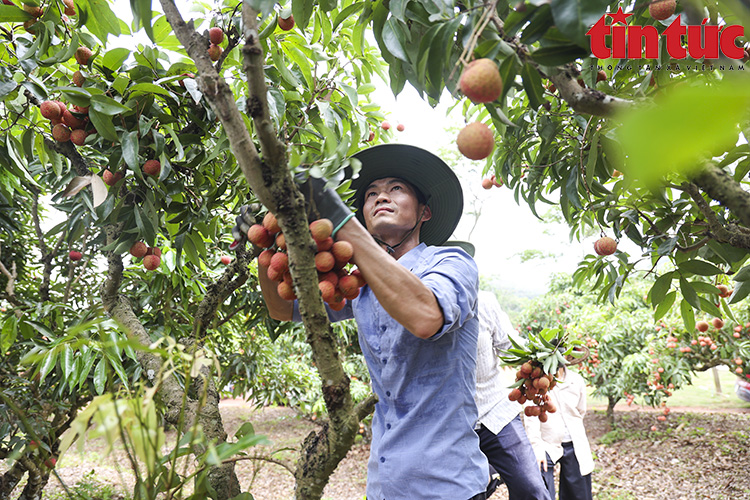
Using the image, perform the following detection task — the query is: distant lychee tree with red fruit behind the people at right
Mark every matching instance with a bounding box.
[517,275,750,427]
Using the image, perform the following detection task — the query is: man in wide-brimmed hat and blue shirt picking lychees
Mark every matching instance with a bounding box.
[235,144,489,500]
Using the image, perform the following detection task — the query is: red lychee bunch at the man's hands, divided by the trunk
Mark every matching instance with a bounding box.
[247,212,365,311]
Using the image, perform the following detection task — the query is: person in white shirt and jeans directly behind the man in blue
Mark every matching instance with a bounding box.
[470,290,550,500]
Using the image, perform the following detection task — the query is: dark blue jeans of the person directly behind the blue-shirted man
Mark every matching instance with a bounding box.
[476,417,550,500]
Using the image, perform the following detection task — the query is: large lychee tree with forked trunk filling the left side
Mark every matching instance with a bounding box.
[0,0,396,498]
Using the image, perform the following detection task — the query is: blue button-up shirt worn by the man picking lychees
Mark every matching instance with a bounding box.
[295,244,489,500]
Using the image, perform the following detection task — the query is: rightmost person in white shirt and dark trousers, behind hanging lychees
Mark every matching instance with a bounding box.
[524,356,594,500]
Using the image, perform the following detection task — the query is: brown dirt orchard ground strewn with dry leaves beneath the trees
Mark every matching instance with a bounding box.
[39,400,750,500]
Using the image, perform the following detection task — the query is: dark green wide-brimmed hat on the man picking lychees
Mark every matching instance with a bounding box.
[351,144,464,245]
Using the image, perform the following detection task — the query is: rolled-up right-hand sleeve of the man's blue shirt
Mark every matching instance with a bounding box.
[415,248,479,340]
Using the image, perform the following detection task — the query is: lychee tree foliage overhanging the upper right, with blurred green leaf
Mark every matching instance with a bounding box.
[358,0,750,324]
